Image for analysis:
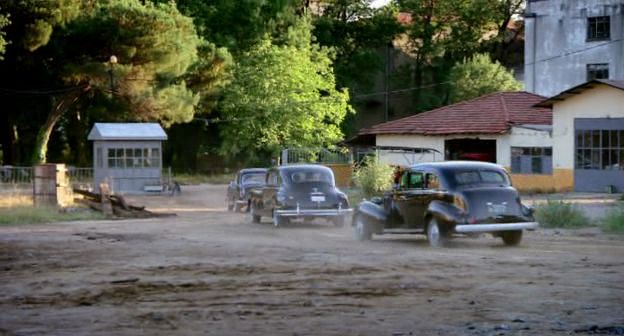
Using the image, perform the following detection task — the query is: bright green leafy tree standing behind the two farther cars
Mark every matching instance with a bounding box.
[221,18,351,159]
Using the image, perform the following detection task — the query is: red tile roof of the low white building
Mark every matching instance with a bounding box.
[359,92,552,135]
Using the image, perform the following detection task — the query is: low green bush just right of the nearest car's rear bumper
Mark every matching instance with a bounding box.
[535,201,589,228]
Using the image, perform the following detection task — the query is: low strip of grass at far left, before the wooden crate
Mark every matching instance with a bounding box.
[0,206,106,225]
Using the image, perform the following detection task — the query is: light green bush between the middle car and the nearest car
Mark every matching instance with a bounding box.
[355,156,394,198]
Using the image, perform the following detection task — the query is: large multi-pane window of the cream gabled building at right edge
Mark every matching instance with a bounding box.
[575,130,624,170]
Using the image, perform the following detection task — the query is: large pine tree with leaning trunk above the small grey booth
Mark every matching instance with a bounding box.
[0,0,230,162]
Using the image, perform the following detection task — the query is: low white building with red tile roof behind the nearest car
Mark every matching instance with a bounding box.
[352,92,558,190]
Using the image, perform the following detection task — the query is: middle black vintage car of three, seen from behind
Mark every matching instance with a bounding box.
[251,164,352,226]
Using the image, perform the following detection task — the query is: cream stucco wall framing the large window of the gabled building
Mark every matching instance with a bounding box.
[553,85,624,170]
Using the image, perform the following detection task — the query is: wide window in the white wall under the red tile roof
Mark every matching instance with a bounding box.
[511,147,552,174]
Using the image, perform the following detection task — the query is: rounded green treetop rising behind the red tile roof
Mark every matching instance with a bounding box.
[450,54,522,102]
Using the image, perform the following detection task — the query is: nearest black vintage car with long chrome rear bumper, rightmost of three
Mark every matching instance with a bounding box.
[353,161,538,247]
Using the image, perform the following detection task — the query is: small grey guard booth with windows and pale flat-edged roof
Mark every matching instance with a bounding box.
[88,123,167,194]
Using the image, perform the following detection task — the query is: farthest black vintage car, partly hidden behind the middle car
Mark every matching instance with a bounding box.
[226,168,267,211]
